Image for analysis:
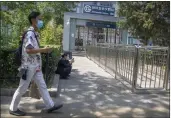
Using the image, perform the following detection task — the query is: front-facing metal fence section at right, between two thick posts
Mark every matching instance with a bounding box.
[136,47,170,89]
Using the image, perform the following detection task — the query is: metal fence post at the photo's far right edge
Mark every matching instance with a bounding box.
[164,47,170,90]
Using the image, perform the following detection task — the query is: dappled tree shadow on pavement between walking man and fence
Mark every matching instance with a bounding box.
[56,56,170,118]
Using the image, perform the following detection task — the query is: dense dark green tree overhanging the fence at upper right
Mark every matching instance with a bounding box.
[118,1,170,46]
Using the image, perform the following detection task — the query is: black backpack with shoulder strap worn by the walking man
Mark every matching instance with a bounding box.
[14,30,39,66]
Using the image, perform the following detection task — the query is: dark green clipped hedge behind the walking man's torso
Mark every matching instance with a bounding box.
[0,46,61,88]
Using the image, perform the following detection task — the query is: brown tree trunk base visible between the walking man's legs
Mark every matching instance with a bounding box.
[29,81,40,99]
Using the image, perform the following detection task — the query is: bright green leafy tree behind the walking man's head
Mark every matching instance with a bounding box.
[0,1,75,47]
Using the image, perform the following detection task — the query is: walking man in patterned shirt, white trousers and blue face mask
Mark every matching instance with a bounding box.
[9,12,63,116]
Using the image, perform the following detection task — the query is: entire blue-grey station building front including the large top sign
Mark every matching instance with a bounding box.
[63,1,132,51]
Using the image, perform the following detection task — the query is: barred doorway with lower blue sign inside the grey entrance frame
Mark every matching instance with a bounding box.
[75,22,122,51]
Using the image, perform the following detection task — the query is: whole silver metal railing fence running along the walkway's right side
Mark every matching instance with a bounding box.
[87,45,170,91]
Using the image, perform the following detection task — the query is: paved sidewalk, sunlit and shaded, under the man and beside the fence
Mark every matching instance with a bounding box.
[1,56,170,118]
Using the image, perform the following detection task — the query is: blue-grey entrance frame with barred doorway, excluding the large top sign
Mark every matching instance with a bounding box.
[62,12,127,52]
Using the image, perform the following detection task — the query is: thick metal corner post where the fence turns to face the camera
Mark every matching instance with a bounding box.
[132,47,139,92]
